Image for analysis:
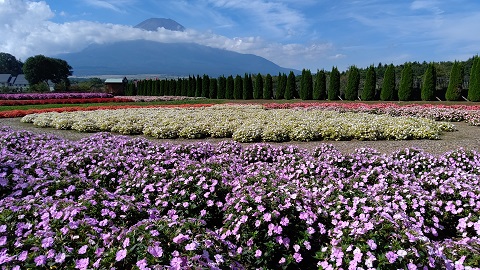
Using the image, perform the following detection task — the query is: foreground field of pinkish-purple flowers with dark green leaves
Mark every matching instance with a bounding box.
[0,129,480,269]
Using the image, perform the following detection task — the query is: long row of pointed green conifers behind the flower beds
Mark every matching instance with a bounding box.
[125,56,480,102]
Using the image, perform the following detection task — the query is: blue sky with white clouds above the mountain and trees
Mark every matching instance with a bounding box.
[0,0,480,72]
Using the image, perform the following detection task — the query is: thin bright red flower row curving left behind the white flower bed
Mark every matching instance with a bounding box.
[0,104,214,118]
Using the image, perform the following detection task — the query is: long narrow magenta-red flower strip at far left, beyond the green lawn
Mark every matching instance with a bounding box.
[0,98,132,106]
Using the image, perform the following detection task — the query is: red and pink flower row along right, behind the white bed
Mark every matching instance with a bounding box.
[264,102,480,126]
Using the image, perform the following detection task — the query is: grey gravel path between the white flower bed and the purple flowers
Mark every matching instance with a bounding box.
[0,118,480,155]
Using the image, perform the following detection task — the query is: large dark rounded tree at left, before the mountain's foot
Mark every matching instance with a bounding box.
[23,55,72,85]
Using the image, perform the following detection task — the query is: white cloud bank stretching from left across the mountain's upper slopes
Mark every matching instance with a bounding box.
[0,0,332,67]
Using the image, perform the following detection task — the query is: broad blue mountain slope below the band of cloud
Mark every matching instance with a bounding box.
[55,40,298,77]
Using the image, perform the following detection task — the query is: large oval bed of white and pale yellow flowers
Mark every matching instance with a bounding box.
[22,105,454,142]
